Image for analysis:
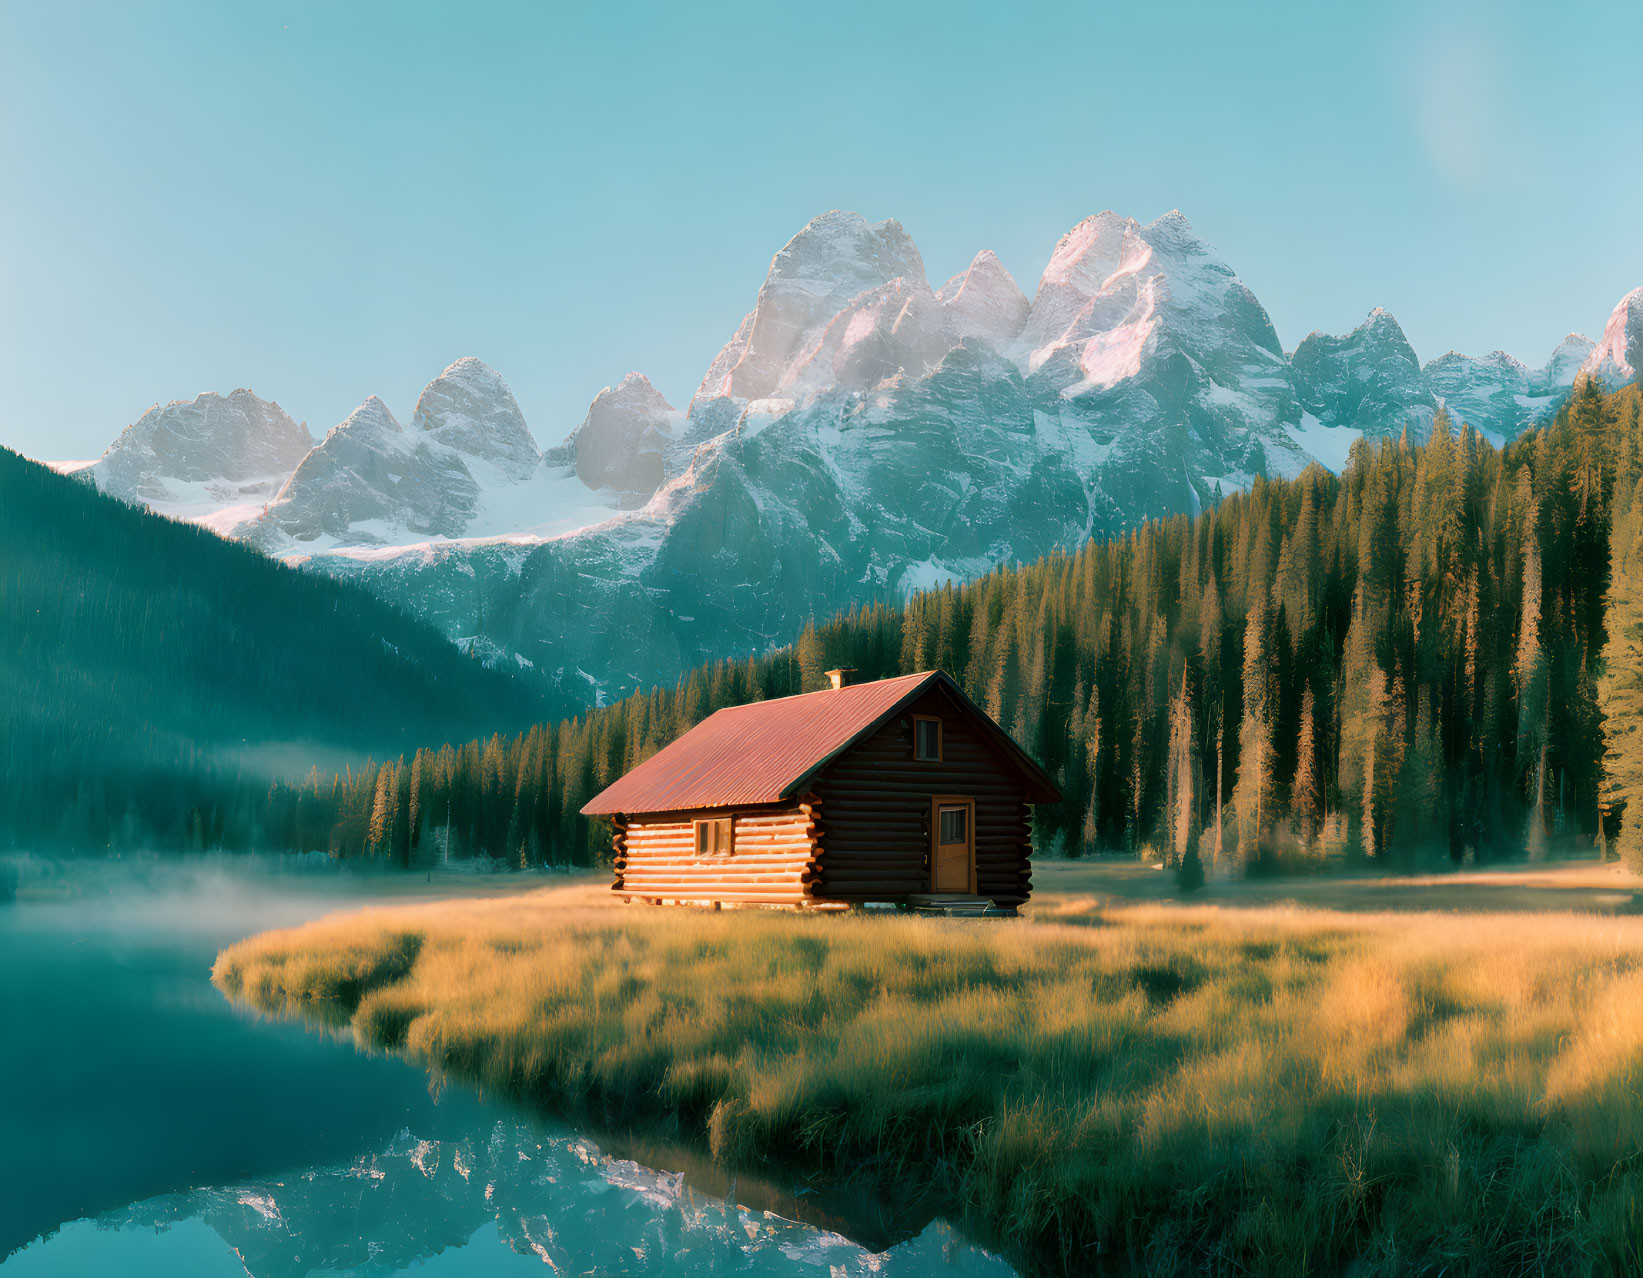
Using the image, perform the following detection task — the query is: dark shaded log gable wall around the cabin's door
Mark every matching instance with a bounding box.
[813,690,1032,905]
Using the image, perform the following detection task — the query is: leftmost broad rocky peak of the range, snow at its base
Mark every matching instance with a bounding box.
[80,389,314,532]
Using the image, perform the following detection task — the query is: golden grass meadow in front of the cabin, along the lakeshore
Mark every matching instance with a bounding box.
[214,862,1643,1275]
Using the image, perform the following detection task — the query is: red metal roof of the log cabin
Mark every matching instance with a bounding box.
[582,670,1058,816]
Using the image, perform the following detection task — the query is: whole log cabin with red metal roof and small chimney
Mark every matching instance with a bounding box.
[582,670,1061,912]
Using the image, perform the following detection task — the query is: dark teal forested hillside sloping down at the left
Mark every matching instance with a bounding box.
[0,448,555,848]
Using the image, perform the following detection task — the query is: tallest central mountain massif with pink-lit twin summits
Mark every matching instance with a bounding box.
[279,214,1313,696]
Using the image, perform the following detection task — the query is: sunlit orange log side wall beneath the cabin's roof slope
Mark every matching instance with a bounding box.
[611,802,817,905]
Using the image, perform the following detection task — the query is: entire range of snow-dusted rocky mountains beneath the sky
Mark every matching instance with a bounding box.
[57,212,1643,698]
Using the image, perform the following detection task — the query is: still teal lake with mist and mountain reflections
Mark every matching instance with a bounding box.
[0,861,1012,1278]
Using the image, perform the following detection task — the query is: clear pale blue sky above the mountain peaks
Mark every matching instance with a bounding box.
[0,0,1643,457]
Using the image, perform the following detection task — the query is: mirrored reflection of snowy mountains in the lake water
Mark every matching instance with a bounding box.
[97,1119,1012,1278]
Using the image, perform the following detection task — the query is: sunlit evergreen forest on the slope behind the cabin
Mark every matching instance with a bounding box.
[225,384,1643,871]
